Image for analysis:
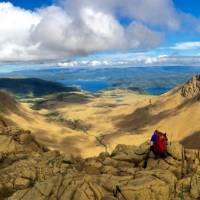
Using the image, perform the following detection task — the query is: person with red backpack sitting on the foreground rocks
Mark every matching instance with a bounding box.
[150,130,168,157]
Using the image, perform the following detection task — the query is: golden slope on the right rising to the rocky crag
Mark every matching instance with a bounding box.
[115,75,200,149]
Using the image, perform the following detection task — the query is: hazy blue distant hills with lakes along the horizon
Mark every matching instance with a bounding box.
[0,66,200,95]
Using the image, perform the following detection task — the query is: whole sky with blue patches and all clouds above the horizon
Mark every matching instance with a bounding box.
[0,0,200,70]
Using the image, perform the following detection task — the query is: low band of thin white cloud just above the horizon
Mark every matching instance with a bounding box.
[58,52,200,68]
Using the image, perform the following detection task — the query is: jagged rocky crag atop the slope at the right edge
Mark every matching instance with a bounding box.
[181,75,200,98]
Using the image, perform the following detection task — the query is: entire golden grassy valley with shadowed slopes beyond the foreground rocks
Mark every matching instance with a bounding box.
[0,76,200,157]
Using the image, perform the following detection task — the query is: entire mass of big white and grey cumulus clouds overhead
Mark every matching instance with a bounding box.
[0,0,198,62]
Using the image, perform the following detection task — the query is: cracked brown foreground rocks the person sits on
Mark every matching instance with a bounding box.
[0,127,200,200]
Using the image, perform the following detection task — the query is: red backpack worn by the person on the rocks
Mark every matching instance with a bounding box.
[154,132,167,155]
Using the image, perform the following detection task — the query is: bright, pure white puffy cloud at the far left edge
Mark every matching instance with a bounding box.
[0,3,40,60]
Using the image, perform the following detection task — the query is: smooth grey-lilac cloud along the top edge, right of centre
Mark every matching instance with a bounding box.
[63,0,180,30]
